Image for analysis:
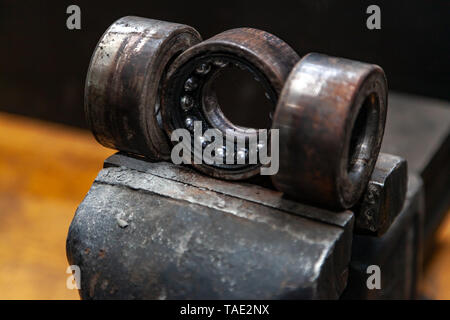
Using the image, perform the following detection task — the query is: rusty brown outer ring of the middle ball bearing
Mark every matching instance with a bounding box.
[162,28,300,180]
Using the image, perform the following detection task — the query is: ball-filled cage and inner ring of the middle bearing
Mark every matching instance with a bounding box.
[169,53,278,171]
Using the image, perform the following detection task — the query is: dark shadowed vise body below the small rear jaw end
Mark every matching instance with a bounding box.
[342,174,424,299]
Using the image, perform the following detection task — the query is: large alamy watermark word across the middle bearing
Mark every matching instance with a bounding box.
[171,121,279,175]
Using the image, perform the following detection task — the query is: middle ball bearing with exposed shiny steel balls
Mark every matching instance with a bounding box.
[162,28,300,180]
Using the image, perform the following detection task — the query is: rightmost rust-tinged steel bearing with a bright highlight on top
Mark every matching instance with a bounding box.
[272,53,387,209]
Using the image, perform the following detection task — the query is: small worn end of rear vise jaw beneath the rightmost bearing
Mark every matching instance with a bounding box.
[353,153,408,236]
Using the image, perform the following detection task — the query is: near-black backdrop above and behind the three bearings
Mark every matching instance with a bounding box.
[0,0,450,127]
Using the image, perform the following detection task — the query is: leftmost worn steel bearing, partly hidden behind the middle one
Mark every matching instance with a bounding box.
[85,17,201,159]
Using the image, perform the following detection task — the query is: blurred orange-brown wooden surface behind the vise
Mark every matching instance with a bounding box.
[0,113,450,299]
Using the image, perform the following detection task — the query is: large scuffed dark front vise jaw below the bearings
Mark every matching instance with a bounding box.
[67,156,353,299]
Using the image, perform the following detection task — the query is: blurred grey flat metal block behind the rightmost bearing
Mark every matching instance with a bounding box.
[381,93,450,254]
